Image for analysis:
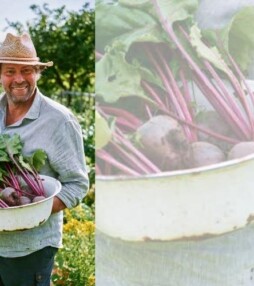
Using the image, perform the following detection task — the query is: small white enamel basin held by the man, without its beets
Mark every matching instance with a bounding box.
[0,175,61,231]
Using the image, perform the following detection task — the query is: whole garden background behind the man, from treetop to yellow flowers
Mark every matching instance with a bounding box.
[3,3,95,286]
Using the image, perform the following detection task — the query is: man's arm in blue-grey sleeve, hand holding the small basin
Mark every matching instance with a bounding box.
[50,120,89,213]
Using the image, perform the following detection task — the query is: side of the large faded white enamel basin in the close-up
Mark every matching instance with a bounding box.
[96,154,254,241]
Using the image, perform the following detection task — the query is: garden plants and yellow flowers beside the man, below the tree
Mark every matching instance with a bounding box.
[52,94,95,286]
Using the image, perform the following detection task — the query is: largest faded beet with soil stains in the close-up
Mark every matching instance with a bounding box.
[137,115,188,170]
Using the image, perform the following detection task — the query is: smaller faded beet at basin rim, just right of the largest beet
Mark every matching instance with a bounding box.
[186,141,226,168]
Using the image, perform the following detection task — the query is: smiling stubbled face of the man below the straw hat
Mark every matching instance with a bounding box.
[0,64,38,104]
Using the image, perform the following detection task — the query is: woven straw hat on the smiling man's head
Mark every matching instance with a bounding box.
[0,33,53,68]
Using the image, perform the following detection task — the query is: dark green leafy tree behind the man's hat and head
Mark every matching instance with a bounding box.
[8,4,95,105]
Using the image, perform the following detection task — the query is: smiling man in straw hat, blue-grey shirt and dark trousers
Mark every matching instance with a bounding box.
[0,33,88,286]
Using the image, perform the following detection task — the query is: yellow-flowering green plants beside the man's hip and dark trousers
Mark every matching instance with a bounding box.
[52,204,95,286]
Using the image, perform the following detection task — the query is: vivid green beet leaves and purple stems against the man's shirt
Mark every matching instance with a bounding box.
[0,134,47,207]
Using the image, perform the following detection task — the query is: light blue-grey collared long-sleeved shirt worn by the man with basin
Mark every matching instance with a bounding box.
[0,90,88,257]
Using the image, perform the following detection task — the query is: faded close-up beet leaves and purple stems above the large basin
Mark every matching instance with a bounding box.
[96,0,254,176]
